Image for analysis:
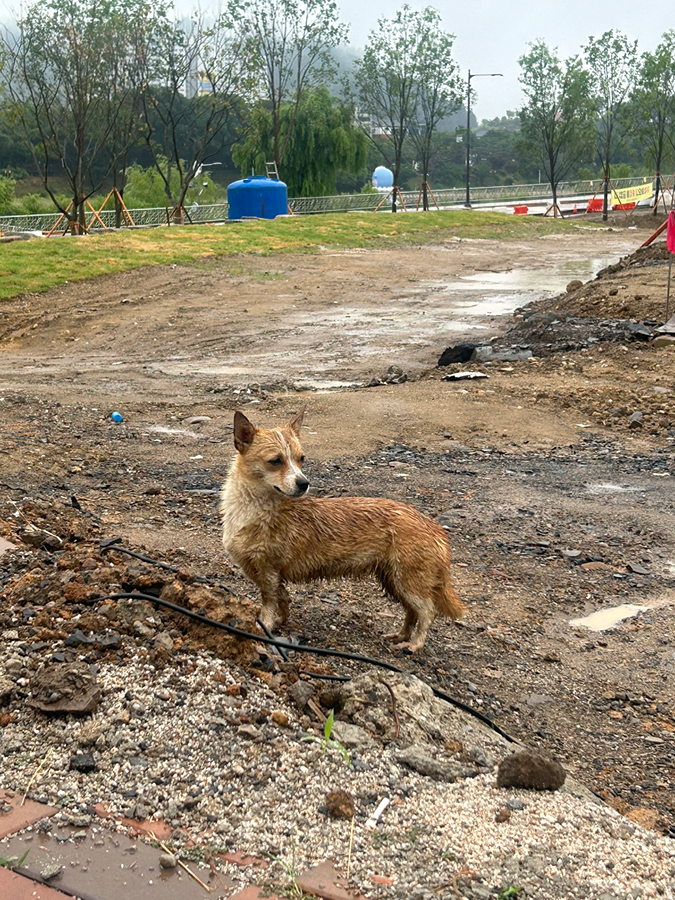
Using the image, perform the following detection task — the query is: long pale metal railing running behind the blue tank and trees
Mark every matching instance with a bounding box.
[0,176,669,234]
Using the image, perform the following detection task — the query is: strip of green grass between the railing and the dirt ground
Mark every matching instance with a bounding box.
[0,210,574,300]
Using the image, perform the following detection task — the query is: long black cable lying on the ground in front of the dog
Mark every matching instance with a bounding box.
[89,591,518,744]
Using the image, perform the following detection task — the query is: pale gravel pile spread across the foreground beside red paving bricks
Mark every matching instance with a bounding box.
[0,641,675,900]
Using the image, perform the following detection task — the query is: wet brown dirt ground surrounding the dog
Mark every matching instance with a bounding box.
[0,223,675,833]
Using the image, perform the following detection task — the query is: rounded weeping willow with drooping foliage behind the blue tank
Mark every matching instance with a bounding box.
[232,87,367,197]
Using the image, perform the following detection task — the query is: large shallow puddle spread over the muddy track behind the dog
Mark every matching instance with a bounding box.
[135,253,632,391]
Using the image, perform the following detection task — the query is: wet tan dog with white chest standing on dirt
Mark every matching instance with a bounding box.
[220,412,464,651]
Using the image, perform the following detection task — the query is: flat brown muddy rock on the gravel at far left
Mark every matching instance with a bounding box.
[27,663,101,715]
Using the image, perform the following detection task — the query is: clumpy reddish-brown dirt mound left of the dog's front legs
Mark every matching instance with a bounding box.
[0,502,257,665]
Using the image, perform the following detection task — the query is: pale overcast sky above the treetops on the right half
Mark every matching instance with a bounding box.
[338,0,675,120]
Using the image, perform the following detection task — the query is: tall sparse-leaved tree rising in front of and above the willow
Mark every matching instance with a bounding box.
[230,0,348,181]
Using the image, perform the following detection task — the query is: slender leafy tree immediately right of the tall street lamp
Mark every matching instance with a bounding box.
[519,40,595,215]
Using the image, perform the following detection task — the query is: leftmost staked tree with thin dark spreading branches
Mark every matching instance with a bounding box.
[3,0,137,233]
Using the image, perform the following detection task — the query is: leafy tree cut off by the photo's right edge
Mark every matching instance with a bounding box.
[632,29,675,212]
